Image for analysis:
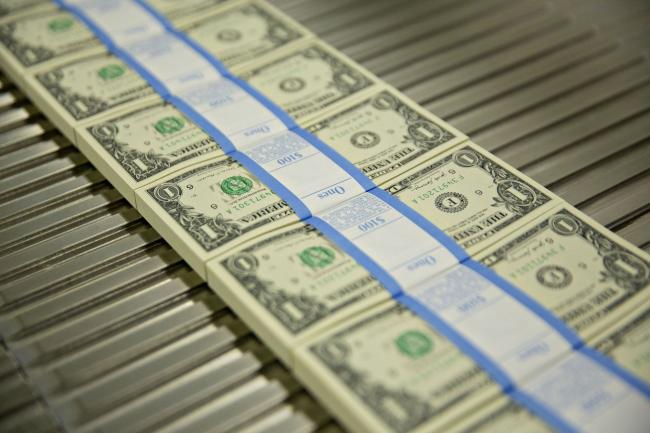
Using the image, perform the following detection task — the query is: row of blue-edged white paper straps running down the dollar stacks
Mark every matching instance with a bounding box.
[56,0,650,432]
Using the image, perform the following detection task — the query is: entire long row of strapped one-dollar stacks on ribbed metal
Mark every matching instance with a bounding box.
[0,0,650,432]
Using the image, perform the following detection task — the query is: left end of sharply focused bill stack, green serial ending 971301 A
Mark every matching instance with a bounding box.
[136,157,298,278]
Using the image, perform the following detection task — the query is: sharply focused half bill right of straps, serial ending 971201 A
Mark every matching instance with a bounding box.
[384,143,559,255]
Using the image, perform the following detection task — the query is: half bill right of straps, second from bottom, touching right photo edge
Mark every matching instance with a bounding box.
[479,205,650,340]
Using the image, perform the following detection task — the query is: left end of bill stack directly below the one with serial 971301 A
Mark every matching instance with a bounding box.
[207,222,390,365]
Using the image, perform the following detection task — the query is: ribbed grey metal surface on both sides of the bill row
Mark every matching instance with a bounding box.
[0,0,650,433]
